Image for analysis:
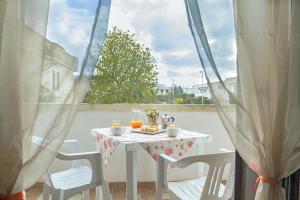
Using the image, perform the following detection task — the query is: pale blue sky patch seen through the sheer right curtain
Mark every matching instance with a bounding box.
[199,0,236,72]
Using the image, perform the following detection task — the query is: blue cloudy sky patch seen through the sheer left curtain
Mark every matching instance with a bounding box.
[47,0,98,60]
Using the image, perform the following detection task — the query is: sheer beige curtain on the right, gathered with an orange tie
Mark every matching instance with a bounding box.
[185,0,300,200]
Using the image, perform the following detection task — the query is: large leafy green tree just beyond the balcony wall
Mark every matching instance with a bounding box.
[85,27,158,103]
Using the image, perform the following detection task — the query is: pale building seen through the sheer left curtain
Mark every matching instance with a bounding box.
[24,26,78,103]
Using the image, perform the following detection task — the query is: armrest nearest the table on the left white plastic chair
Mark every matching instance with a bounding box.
[56,151,103,184]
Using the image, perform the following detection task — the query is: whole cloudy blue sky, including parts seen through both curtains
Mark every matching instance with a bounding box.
[47,0,236,86]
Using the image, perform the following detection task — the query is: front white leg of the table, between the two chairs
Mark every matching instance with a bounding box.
[126,151,137,200]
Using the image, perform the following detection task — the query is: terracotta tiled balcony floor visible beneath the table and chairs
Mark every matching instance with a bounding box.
[26,182,168,200]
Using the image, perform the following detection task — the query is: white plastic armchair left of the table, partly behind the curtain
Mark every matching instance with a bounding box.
[43,140,111,200]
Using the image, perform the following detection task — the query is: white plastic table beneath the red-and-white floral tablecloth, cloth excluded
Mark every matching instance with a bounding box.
[91,128,211,200]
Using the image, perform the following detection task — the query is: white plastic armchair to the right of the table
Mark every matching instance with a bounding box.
[156,152,235,200]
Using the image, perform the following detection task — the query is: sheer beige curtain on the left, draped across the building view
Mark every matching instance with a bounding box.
[0,0,110,196]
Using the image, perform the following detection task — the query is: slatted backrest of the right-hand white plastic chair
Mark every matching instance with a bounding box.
[200,152,235,200]
